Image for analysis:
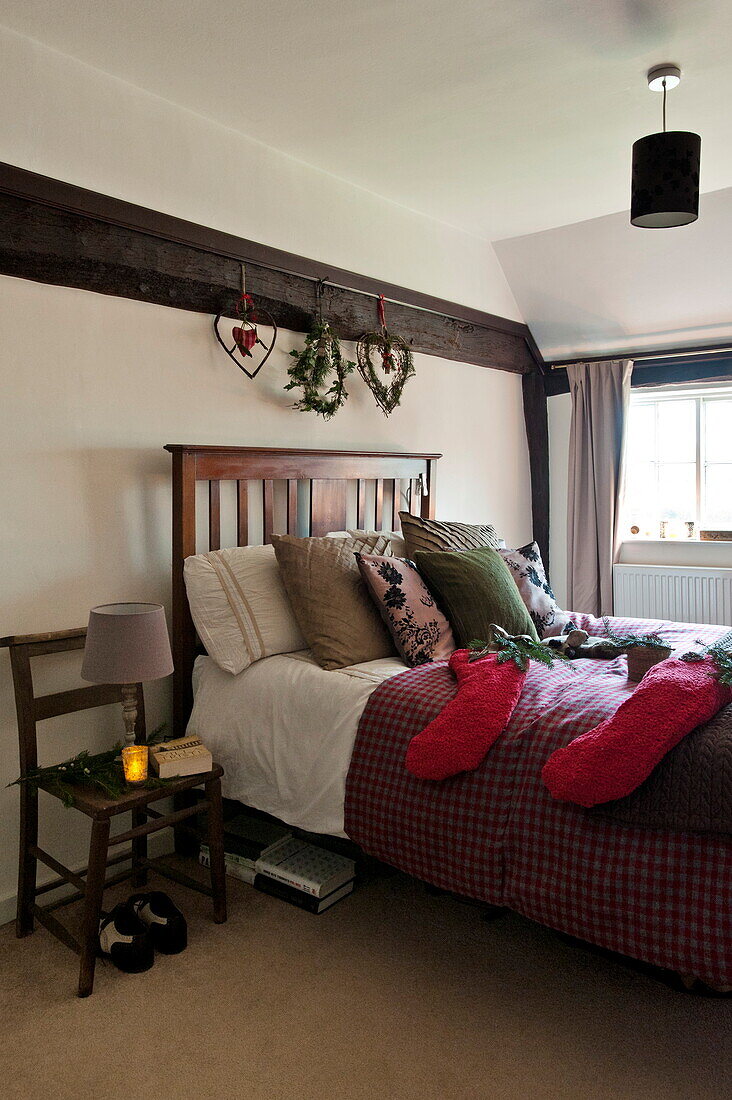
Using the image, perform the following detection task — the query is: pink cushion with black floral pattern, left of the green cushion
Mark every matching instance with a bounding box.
[356,553,456,667]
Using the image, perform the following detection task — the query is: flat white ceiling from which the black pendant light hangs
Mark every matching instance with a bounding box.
[0,0,732,240]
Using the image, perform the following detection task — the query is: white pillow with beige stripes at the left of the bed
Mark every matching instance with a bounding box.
[183,546,307,674]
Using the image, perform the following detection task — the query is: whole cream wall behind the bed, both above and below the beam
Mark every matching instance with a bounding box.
[0,29,532,923]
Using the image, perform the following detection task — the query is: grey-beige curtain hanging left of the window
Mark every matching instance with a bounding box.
[567,359,633,615]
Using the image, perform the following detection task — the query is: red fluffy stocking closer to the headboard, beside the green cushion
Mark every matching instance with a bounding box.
[406,649,526,779]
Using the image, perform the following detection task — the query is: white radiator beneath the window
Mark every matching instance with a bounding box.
[613,565,732,626]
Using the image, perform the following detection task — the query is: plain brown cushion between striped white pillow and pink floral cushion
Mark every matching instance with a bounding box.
[272,535,394,669]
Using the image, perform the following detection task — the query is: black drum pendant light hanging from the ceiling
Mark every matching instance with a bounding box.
[631,65,701,229]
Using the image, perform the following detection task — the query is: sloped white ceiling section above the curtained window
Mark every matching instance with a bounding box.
[493,188,732,360]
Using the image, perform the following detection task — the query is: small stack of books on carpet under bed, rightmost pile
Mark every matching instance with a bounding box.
[253,837,356,913]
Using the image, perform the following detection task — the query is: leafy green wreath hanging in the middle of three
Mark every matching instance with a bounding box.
[285,279,356,420]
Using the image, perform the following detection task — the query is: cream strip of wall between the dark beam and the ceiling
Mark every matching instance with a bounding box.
[0,28,521,320]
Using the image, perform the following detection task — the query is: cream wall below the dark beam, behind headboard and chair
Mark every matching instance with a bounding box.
[0,272,532,921]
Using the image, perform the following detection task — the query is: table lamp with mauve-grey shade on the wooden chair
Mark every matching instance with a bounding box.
[81,604,173,745]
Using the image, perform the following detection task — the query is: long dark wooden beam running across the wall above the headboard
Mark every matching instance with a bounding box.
[0,165,536,374]
